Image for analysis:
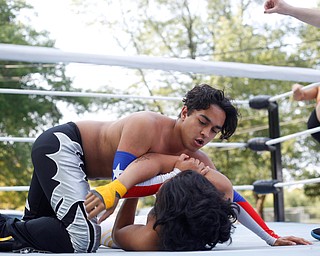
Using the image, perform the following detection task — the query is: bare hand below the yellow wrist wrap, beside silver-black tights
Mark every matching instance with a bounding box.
[84,192,119,223]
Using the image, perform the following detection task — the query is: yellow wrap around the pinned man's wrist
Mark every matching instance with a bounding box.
[94,180,127,209]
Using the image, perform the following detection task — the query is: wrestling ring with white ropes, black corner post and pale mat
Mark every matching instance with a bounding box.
[0,44,320,256]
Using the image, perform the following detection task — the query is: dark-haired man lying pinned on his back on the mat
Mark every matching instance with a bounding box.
[101,171,237,251]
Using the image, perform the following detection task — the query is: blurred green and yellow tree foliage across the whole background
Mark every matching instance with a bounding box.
[0,0,320,210]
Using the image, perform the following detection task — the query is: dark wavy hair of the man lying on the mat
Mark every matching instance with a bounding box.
[153,170,238,251]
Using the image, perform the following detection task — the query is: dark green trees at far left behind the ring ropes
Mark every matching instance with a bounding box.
[0,0,100,208]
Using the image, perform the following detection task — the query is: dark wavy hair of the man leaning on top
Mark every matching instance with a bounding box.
[179,84,239,139]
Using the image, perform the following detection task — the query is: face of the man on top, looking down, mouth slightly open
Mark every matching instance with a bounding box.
[181,105,226,151]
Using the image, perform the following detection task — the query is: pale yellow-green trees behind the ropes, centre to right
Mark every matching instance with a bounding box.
[70,0,319,218]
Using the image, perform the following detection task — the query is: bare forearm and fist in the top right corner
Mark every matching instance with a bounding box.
[264,0,320,27]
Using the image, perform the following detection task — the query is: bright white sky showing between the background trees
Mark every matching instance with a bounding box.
[23,0,317,121]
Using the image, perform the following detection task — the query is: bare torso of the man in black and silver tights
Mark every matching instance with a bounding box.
[76,112,202,179]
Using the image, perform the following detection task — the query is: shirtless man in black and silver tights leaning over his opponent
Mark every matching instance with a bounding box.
[0,85,306,252]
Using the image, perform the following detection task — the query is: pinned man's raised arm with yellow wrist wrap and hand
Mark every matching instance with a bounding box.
[85,153,207,222]
